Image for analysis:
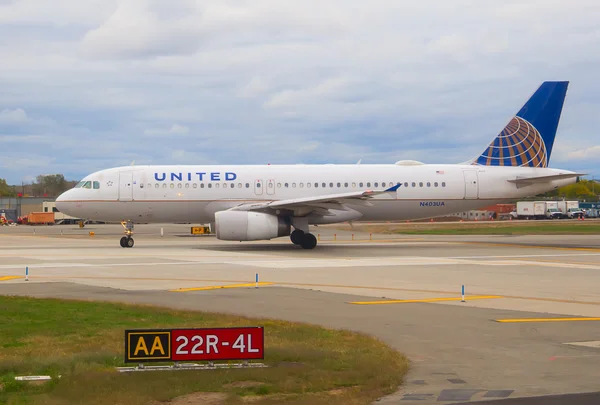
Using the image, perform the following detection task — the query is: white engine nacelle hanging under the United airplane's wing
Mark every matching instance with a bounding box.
[215,211,290,241]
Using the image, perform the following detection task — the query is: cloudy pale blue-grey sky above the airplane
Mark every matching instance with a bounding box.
[0,0,600,184]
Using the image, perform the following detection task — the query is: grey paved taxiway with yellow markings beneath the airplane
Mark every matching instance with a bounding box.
[0,225,600,404]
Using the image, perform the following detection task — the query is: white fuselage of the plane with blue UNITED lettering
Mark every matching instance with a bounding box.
[57,164,576,224]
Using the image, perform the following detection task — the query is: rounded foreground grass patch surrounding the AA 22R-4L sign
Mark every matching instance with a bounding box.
[0,297,408,405]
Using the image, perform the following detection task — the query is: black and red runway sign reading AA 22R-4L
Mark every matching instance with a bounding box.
[125,327,264,363]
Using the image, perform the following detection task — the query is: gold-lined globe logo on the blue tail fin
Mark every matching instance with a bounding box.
[473,117,548,167]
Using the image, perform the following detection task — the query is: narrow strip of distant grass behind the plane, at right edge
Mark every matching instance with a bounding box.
[385,223,600,235]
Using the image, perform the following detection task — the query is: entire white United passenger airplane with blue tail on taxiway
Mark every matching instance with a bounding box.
[56,81,582,249]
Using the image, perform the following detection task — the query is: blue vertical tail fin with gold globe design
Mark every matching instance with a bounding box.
[473,82,569,167]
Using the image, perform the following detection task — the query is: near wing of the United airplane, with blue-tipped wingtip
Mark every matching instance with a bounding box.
[229,184,400,216]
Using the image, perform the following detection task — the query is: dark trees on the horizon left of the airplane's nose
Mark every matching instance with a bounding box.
[0,174,77,198]
